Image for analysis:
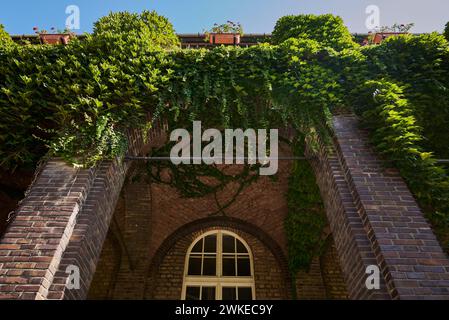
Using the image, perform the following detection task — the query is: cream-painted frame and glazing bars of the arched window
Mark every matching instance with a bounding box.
[181,230,256,300]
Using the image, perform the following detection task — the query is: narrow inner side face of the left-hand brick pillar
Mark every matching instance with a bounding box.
[45,161,129,300]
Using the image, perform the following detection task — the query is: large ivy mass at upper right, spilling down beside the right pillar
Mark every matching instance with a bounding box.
[345,33,449,249]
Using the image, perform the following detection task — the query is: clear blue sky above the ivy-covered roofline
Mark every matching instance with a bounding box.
[0,0,449,34]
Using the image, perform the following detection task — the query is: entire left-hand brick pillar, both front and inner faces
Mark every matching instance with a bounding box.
[0,124,166,299]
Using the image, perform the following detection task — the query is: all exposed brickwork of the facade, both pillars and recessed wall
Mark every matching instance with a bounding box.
[0,116,449,299]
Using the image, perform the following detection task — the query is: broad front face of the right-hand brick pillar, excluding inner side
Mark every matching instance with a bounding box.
[328,116,449,299]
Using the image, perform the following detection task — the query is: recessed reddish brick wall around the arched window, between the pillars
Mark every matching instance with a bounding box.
[86,141,344,299]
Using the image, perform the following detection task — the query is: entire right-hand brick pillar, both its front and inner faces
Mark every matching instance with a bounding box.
[310,116,449,299]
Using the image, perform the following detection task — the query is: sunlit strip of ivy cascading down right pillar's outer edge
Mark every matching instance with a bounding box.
[354,80,449,246]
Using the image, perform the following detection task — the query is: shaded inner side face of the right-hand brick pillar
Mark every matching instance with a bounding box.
[307,127,390,300]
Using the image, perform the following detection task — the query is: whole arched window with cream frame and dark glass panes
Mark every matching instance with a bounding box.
[182,230,255,300]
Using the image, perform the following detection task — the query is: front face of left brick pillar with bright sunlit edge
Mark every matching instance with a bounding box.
[0,159,96,299]
